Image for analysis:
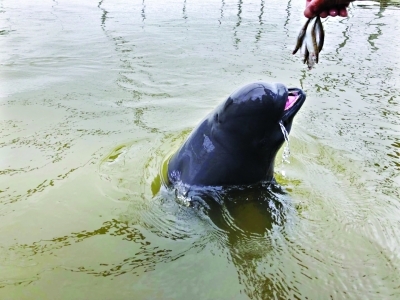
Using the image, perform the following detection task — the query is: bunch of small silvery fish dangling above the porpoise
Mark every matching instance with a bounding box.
[293,16,325,70]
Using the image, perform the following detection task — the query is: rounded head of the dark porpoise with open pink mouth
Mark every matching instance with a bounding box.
[209,82,306,155]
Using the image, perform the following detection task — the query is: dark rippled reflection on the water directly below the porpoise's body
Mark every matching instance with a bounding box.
[180,185,294,299]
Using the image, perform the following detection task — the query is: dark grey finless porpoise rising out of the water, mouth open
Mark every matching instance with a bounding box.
[168,82,306,186]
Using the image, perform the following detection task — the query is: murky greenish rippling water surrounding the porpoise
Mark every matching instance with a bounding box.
[0,0,400,299]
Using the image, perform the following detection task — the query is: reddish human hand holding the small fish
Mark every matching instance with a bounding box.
[304,0,354,18]
